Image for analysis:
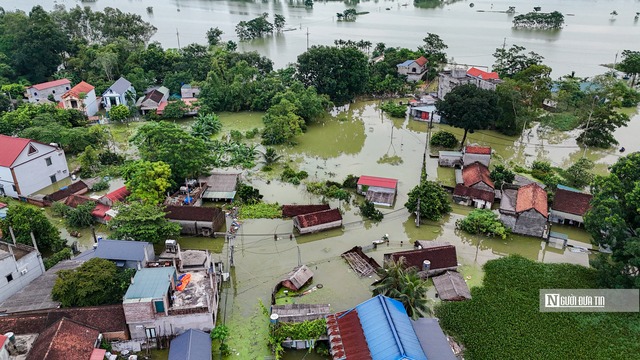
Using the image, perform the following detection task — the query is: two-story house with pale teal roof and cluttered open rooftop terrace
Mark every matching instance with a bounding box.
[122,266,218,340]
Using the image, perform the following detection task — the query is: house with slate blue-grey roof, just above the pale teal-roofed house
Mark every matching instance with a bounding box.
[84,239,156,269]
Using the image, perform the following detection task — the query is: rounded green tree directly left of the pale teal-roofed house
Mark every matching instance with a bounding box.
[51,258,135,307]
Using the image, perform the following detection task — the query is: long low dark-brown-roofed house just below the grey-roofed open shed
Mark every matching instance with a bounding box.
[165,205,225,236]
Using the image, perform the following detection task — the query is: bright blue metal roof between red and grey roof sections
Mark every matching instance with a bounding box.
[356,295,427,360]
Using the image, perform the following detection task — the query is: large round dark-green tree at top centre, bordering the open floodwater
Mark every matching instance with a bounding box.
[297,46,369,104]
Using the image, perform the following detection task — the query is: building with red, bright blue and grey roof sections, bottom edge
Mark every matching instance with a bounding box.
[327,295,456,360]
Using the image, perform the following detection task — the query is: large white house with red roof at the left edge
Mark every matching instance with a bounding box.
[0,135,69,198]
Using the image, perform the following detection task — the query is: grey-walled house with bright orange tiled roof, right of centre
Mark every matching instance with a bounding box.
[500,183,549,238]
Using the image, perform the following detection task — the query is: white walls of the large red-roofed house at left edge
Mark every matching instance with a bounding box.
[11,142,69,196]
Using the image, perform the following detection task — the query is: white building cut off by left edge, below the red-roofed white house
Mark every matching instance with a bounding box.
[0,241,44,303]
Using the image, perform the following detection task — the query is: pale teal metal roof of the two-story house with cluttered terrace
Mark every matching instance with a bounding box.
[124,266,176,303]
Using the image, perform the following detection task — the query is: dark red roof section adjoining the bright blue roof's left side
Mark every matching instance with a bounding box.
[327,309,371,360]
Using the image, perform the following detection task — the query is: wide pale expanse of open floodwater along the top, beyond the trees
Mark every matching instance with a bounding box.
[8,0,640,76]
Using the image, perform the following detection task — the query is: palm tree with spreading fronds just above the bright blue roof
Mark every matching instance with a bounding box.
[373,257,431,320]
